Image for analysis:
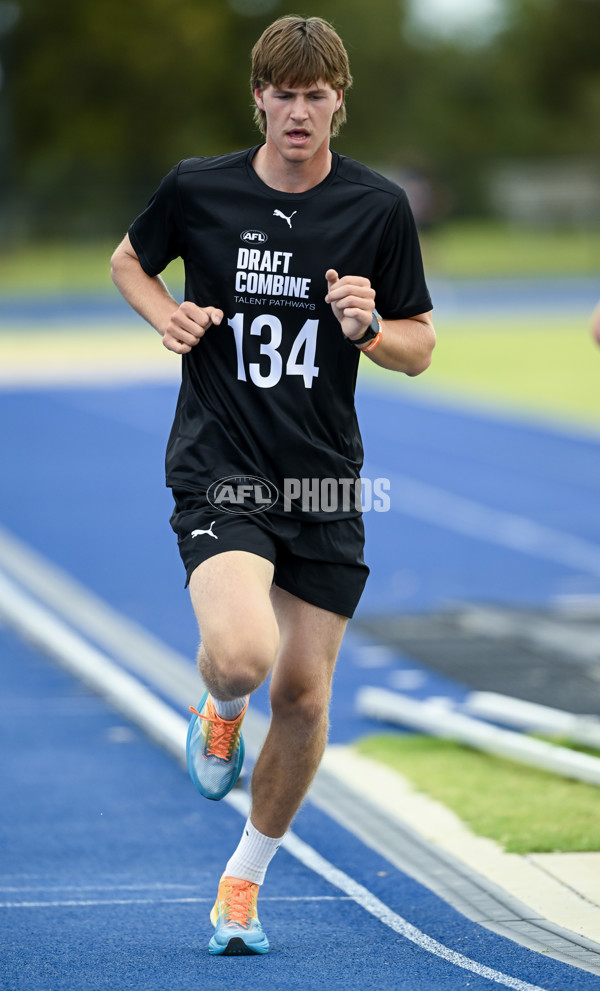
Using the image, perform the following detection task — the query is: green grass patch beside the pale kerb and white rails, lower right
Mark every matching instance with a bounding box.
[356,734,600,854]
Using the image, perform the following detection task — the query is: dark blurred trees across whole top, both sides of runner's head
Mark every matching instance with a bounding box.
[4,0,600,235]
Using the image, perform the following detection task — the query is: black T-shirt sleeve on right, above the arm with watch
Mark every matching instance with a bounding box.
[373,189,433,320]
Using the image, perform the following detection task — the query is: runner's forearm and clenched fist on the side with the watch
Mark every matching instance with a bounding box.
[325,269,435,376]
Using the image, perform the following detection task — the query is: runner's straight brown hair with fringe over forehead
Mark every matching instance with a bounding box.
[250,16,352,137]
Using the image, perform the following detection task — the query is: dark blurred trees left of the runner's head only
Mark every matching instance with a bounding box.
[13,0,262,231]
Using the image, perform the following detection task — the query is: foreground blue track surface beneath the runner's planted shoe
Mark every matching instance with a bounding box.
[0,633,600,991]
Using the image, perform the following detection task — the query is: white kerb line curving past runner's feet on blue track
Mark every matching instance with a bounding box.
[0,572,545,991]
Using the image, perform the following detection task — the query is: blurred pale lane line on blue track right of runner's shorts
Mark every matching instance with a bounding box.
[376,466,600,576]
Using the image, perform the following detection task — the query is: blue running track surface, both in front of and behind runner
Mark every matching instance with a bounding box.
[0,366,600,991]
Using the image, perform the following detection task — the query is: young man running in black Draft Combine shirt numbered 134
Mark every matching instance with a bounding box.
[113,17,435,954]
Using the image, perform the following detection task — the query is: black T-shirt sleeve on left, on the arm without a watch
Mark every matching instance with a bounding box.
[128,166,186,276]
